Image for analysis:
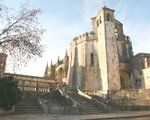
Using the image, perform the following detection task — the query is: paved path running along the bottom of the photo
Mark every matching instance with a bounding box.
[0,111,150,120]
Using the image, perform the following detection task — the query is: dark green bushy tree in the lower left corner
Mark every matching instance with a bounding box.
[0,76,22,110]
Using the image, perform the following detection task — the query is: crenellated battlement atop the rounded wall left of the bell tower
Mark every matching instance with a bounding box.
[70,31,96,46]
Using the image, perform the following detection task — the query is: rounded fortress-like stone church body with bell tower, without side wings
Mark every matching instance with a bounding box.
[67,7,133,93]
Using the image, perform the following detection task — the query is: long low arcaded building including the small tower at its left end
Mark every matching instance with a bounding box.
[0,53,58,92]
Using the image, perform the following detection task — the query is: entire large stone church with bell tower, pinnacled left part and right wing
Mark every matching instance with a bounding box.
[47,6,150,93]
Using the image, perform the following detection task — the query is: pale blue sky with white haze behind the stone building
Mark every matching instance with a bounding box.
[3,0,150,76]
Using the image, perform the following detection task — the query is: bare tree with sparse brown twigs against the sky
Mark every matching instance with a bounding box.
[0,3,44,67]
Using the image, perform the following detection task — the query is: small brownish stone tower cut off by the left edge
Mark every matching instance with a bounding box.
[0,53,7,76]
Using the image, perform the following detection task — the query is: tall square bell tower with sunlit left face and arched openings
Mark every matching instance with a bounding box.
[92,6,120,92]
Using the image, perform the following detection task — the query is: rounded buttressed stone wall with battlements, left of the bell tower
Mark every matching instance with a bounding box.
[68,32,100,90]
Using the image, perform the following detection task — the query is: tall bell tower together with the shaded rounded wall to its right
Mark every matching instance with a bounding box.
[92,7,133,91]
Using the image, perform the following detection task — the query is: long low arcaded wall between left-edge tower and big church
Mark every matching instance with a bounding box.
[5,73,57,92]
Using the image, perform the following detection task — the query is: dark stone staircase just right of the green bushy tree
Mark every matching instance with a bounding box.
[15,92,43,114]
